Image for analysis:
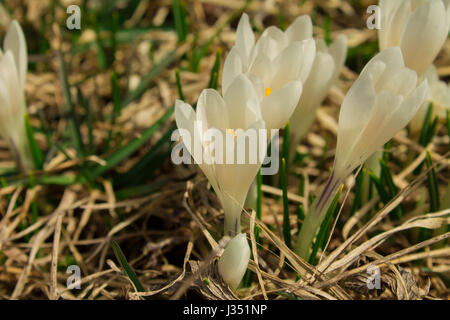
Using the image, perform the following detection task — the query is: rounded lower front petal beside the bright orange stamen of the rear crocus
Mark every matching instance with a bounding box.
[261,81,302,130]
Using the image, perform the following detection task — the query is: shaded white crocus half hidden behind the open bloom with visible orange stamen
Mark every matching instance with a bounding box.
[290,35,347,155]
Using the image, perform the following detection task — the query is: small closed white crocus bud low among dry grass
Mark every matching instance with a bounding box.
[218,233,250,289]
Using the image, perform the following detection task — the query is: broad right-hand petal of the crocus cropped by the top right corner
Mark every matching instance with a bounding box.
[401,1,448,75]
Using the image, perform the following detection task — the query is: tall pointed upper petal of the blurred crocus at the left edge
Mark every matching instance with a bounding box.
[3,20,28,90]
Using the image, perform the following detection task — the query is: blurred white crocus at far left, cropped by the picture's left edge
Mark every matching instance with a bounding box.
[0,20,33,172]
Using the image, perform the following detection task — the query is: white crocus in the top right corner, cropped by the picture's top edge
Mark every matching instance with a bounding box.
[378,0,450,76]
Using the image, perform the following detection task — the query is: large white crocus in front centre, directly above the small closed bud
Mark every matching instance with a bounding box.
[175,74,267,235]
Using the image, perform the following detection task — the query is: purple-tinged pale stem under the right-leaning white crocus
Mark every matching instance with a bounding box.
[295,171,341,260]
